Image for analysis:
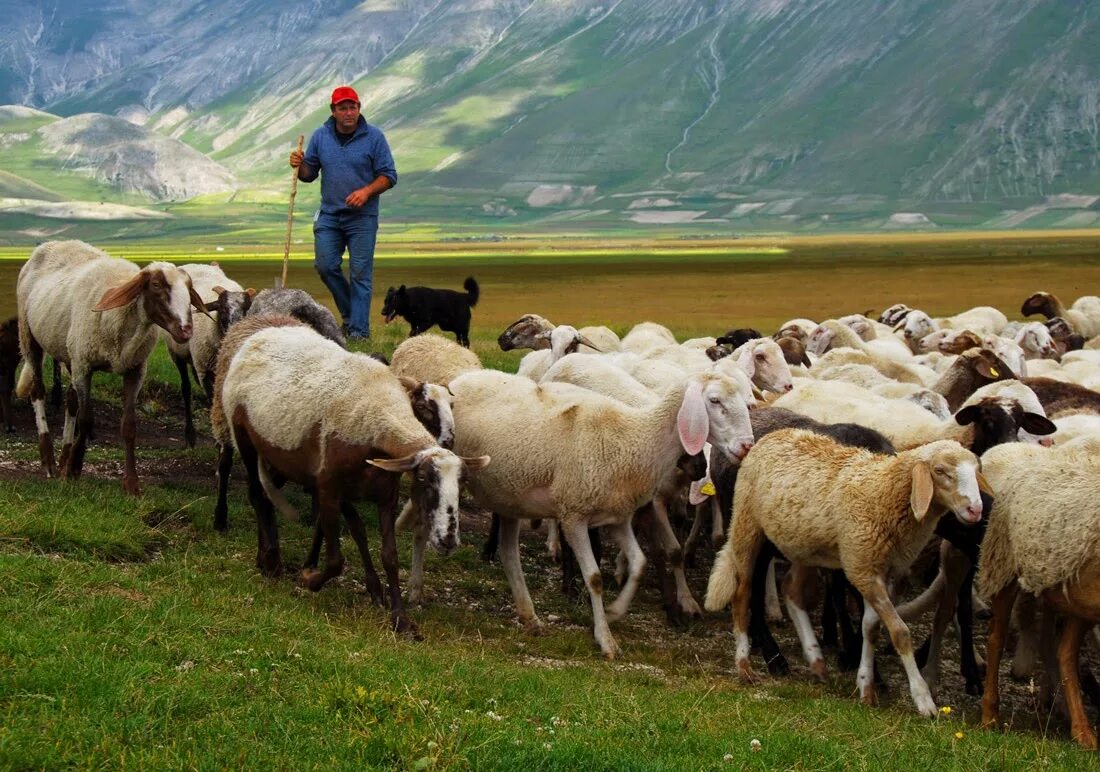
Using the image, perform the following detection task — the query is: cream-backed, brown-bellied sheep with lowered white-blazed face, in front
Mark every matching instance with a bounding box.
[218,327,490,635]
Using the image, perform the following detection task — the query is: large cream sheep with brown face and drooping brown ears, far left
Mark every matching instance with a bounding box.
[15,241,206,495]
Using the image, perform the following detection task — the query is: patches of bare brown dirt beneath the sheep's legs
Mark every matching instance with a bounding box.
[0,385,1100,737]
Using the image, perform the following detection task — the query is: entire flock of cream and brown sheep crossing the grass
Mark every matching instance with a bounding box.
[6,241,1100,747]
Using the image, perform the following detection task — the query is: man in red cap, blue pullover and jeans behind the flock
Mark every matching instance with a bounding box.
[290,86,397,340]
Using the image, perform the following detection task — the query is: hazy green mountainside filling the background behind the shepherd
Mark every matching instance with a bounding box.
[0,0,1100,238]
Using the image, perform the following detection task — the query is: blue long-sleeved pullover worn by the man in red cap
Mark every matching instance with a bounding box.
[300,115,397,217]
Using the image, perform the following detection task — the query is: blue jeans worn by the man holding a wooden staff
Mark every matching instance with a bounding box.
[314,212,378,337]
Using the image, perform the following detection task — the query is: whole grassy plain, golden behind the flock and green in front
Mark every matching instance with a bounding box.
[0,231,1100,770]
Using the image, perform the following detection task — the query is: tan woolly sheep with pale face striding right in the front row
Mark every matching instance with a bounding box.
[705,429,988,717]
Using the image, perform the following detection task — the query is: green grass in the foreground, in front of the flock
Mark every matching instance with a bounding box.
[0,240,1096,770]
